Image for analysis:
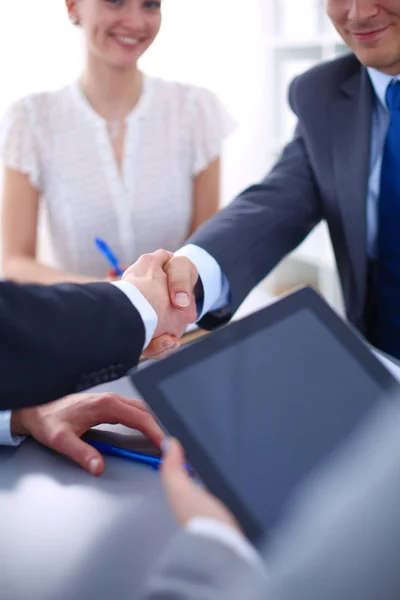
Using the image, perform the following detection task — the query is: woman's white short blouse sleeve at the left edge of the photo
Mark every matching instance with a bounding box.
[0,98,41,190]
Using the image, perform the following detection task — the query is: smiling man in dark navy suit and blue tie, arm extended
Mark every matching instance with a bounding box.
[155,0,400,357]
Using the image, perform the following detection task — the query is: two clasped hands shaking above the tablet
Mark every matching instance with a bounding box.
[121,250,198,358]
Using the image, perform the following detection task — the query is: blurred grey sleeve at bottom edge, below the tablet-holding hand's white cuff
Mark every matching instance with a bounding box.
[140,532,266,600]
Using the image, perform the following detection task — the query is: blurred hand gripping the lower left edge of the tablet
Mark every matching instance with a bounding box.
[161,439,242,533]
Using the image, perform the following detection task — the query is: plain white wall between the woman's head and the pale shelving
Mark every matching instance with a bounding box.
[143,0,268,204]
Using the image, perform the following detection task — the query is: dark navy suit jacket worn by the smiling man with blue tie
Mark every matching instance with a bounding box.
[188,55,374,333]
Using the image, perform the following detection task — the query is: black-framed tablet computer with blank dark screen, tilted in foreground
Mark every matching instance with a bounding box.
[130,288,399,542]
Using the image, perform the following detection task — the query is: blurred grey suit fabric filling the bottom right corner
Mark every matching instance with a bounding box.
[266,396,400,600]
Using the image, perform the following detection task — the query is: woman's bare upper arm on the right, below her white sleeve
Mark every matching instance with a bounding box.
[189,158,221,235]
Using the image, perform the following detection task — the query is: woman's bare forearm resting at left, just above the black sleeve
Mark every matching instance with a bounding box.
[3,256,101,285]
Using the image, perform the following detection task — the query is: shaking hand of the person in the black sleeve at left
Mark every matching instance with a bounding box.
[122,250,197,341]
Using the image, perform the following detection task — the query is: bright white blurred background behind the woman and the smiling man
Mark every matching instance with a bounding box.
[0,0,345,310]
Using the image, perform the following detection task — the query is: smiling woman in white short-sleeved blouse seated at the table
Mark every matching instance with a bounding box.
[1,0,232,283]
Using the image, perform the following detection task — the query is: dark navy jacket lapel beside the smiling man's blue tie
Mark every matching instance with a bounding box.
[332,67,373,313]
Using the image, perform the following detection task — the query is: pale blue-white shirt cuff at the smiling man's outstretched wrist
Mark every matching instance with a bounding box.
[174,244,230,320]
